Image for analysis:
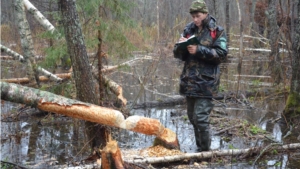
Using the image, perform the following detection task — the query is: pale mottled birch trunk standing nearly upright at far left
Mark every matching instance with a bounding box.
[15,0,39,87]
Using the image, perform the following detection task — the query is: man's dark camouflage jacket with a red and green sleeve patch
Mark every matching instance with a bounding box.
[173,15,228,98]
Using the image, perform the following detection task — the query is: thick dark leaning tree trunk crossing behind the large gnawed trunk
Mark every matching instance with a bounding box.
[59,0,109,149]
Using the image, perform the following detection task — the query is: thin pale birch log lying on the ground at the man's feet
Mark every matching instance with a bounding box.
[124,143,300,164]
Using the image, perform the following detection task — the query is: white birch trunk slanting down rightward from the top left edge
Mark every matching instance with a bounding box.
[23,0,55,33]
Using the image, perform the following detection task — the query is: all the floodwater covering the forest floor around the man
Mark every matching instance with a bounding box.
[1,51,300,168]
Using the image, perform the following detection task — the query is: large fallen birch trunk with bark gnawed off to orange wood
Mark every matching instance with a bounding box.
[0,82,179,149]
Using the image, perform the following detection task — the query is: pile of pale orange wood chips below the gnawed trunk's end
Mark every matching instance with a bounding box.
[146,145,184,157]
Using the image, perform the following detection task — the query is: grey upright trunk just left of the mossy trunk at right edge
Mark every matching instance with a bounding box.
[267,0,283,84]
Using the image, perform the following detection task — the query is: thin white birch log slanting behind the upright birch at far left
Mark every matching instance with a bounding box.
[0,45,62,82]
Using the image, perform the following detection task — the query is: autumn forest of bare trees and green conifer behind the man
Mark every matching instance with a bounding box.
[1,0,300,168]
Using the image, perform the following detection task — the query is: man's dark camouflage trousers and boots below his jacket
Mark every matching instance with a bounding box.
[186,97,214,152]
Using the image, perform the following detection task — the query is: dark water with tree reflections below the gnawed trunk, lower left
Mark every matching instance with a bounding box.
[1,102,89,168]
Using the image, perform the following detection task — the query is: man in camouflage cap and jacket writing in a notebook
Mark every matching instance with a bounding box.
[173,0,228,152]
